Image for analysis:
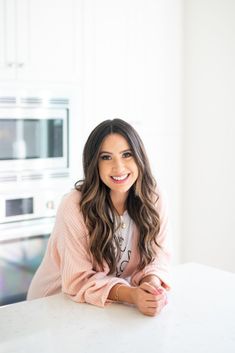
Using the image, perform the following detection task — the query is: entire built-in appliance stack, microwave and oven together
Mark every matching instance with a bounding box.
[0,92,71,305]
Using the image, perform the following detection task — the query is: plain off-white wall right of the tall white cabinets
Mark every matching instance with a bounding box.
[182,0,235,271]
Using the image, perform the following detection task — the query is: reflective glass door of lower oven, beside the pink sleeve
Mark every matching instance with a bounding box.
[0,235,49,305]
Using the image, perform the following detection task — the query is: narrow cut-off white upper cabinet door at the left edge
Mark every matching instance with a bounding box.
[0,0,16,79]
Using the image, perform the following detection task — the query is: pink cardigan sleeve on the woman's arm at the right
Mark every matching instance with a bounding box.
[131,187,171,288]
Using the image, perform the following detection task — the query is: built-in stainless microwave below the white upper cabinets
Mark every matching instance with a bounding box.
[0,97,69,173]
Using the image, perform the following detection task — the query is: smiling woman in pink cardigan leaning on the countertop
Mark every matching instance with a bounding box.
[28,119,170,316]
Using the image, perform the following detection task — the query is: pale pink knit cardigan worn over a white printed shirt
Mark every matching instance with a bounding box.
[27,190,170,306]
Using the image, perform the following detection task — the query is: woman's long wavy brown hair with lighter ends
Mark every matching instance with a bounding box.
[75,119,160,273]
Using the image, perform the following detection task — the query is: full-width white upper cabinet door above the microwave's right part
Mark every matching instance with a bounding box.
[17,0,79,82]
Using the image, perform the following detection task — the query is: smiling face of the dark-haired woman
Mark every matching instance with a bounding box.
[98,133,139,197]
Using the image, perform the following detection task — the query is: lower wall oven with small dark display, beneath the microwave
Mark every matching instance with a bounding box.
[0,174,69,305]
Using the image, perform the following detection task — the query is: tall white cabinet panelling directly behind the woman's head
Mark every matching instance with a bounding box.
[74,0,182,262]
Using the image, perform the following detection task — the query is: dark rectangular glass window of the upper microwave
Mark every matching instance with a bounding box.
[0,118,64,160]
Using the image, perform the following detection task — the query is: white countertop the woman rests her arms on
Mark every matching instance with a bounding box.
[0,264,235,353]
